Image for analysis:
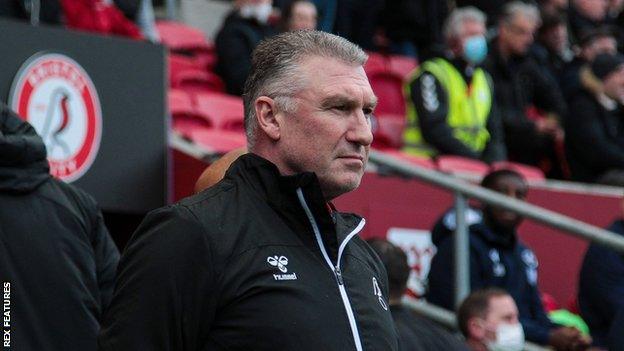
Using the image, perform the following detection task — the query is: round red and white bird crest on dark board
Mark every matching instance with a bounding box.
[9,53,102,182]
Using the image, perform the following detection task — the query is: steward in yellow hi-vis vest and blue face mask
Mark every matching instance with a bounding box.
[404,7,506,162]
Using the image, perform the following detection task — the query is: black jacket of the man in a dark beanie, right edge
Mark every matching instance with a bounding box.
[564,91,624,182]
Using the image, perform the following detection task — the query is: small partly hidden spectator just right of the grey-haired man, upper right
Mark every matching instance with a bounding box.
[531,14,574,83]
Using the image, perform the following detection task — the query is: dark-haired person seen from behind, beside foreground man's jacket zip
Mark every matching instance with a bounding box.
[368,239,467,351]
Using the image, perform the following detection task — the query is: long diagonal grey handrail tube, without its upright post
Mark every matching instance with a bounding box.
[369,150,624,253]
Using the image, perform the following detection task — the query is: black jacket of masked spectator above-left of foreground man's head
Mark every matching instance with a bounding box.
[215,11,275,95]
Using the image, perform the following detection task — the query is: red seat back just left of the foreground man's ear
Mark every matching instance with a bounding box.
[195,93,245,132]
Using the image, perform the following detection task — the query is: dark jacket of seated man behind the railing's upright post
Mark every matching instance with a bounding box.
[427,209,553,344]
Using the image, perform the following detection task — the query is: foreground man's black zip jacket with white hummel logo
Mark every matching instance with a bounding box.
[99,154,398,351]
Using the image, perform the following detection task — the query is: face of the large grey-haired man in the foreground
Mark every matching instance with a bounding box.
[276,57,377,200]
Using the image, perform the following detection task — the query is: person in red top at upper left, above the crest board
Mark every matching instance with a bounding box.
[61,0,143,39]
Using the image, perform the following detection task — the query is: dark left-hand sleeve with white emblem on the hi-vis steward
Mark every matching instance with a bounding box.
[410,72,479,159]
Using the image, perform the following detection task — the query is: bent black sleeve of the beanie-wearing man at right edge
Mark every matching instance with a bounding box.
[565,98,624,169]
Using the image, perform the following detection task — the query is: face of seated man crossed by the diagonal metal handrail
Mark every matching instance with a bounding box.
[486,175,528,229]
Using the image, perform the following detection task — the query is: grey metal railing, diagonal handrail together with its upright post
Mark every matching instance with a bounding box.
[369,150,624,350]
